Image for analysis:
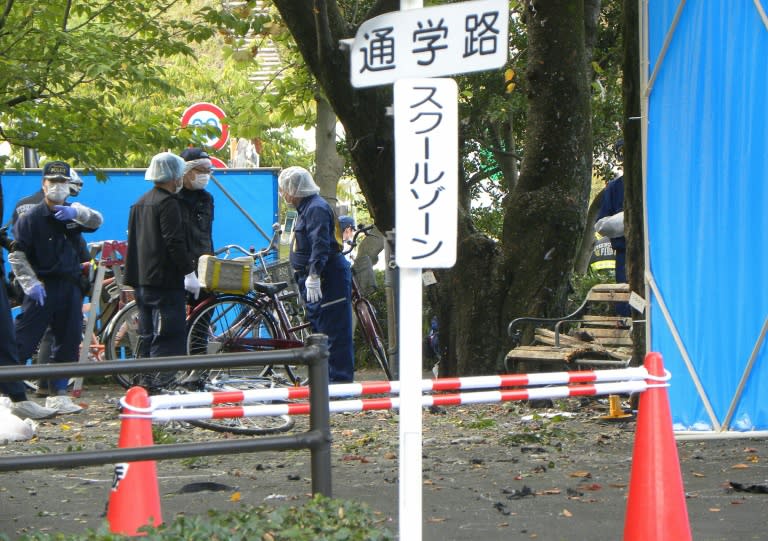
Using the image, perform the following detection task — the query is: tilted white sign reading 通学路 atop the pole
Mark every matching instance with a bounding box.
[350,0,509,88]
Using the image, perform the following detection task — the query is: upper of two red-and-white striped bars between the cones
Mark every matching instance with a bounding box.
[150,366,648,415]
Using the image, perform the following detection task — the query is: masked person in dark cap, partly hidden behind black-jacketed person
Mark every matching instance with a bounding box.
[179,147,213,300]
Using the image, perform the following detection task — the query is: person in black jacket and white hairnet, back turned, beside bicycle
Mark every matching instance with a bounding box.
[125,152,200,357]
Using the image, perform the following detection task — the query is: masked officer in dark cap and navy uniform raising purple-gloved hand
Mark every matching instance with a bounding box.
[8,161,103,413]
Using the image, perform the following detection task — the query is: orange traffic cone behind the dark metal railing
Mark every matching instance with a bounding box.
[107,387,163,535]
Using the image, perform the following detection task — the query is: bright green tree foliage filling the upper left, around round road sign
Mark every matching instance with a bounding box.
[0,0,314,172]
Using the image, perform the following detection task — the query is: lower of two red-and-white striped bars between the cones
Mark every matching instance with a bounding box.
[130,380,649,422]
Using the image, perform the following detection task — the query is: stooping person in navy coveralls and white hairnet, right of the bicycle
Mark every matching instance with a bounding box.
[278,167,355,382]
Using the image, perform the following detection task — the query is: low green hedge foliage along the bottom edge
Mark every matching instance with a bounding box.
[10,495,395,541]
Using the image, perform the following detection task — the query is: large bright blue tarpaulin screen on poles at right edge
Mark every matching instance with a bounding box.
[640,0,768,431]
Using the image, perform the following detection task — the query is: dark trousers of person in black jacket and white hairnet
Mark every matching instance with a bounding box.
[136,286,187,357]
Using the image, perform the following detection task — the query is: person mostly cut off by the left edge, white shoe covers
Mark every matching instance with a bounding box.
[0,177,58,419]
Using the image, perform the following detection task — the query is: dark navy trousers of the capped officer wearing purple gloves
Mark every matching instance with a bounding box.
[16,278,83,393]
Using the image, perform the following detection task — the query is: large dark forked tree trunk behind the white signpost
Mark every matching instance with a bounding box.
[275,0,593,375]
